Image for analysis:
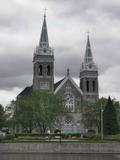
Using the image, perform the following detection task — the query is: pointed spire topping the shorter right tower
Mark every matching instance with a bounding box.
[84,33,93,63]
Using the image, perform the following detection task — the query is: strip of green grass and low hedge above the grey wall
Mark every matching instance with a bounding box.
[0,134,120,144]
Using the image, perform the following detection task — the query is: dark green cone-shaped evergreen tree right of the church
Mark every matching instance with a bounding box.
[103,97,119,134]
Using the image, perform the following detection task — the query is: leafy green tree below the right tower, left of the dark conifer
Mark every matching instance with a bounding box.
[82,98,107,132]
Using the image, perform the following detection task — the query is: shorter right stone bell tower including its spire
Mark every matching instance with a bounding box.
[80,35,99,100]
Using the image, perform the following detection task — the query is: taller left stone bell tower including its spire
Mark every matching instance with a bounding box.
[33,15,54,91]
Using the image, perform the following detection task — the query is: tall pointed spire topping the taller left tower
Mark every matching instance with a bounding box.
[39,13,49,48]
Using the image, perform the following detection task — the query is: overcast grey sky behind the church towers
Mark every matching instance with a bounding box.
[0,0,120,106]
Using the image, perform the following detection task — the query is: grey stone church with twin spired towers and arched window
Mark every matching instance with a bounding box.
[19,15,99,133]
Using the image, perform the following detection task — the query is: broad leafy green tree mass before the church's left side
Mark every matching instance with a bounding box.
[13,91,67,133]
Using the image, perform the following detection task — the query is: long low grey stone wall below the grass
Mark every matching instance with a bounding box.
[0,143,120,154]
